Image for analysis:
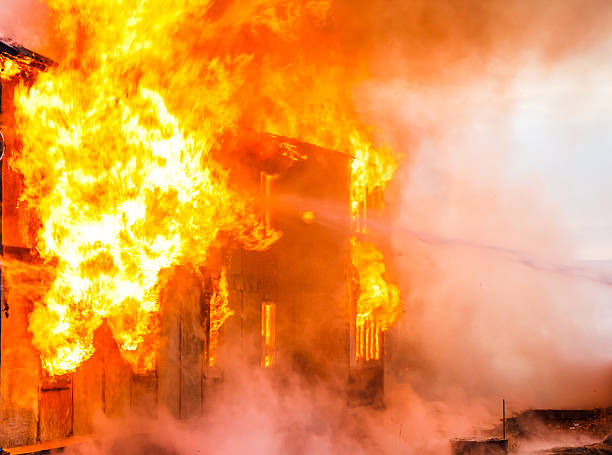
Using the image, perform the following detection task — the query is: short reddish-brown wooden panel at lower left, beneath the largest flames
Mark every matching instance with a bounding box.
[38,386,72,441]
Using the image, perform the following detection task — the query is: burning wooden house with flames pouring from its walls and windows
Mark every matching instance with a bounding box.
[0,33,401,447]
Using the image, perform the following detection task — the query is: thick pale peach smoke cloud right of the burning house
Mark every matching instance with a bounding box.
[356,2,612,411]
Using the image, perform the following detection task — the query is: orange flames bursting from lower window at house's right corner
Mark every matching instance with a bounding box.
[351,237,402,361]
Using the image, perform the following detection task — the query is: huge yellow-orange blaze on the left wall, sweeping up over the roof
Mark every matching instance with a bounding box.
[8,0,402,374]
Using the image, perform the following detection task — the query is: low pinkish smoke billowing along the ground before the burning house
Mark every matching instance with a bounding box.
[62,372,488,455]
